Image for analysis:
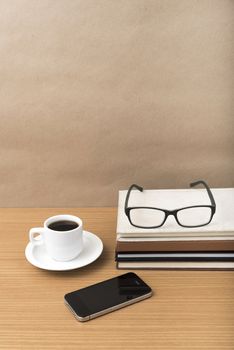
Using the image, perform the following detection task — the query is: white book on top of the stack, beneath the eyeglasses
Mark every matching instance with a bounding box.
[117,188,234,240]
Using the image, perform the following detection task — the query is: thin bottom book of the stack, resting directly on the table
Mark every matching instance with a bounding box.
[116,261,234,270]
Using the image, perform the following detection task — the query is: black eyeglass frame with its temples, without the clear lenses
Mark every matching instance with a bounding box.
[124,180,216,229]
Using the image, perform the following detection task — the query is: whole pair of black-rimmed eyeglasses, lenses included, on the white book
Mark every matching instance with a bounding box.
[124,180,216,229]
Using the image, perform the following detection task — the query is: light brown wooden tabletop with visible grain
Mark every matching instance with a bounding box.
[0,208,234,350]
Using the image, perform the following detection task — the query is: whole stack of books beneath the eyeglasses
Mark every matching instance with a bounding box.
[115,188,234,269]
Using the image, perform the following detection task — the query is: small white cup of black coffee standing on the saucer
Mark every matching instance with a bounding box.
[29,215,83,261]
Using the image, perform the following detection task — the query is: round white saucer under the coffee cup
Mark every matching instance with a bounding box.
[25,231,103,271]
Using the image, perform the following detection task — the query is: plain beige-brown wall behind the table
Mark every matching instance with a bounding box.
[0,0,234,207]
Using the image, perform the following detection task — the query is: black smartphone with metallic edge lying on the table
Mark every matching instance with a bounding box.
[64,272,152,322]
